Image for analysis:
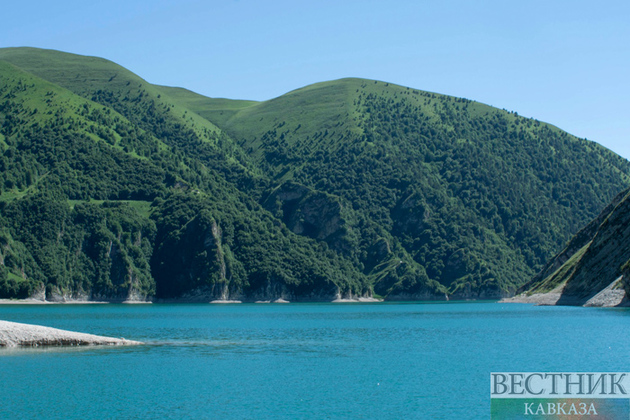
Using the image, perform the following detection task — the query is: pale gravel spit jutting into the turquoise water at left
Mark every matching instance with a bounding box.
[0,321,142,347]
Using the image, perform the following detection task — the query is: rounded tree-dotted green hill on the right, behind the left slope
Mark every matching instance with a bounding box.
[173,79,628,297]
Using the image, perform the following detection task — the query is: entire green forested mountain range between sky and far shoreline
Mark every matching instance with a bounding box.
[0,48,630,300]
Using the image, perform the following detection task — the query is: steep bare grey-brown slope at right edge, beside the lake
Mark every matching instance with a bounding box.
[516,190,630,306]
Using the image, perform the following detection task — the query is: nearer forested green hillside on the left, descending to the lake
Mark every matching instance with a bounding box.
[0,49,369,301]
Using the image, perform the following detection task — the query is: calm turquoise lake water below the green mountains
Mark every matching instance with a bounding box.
[0,302,630,419]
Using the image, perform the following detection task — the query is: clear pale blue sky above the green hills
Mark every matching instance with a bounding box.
[0,0,630,159]
